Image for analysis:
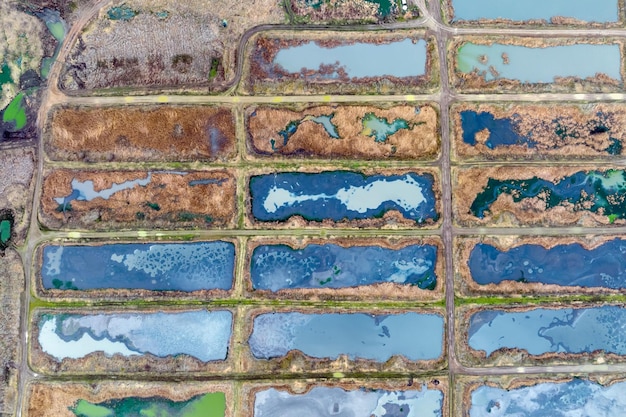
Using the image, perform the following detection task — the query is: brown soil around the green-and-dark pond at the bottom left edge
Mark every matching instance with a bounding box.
[26,381,234,417]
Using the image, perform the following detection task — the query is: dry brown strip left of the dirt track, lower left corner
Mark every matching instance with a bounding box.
[0,249,24,416]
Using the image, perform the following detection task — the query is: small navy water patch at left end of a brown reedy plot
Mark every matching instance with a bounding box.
[460,110,537,149]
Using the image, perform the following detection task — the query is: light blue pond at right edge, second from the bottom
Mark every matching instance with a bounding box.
[468,306,626,356]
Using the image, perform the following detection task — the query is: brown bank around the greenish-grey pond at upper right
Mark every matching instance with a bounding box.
[448,36,626,93]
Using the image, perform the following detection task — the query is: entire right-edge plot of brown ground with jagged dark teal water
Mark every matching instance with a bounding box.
[452,165,626,227]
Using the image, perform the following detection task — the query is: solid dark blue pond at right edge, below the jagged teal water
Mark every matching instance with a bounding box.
[468,239,626,288]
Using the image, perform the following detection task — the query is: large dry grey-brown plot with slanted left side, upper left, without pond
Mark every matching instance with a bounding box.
[60,0,284,90]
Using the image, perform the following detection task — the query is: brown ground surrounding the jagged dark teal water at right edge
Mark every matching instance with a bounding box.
[452,166,626,227]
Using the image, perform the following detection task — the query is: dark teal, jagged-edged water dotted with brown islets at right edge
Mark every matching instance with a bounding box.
[470,170,626,222]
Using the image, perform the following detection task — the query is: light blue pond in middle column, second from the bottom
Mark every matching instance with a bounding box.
[249,312,444,362]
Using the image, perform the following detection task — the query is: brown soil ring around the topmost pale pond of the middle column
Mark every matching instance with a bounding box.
[244,31,439,95]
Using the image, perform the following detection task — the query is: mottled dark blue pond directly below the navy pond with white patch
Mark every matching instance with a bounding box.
[250,244,437,291]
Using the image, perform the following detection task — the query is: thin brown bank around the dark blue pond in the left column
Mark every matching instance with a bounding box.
[31,238,240,302]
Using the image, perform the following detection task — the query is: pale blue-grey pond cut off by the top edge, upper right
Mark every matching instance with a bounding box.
[452,0,619,23]
